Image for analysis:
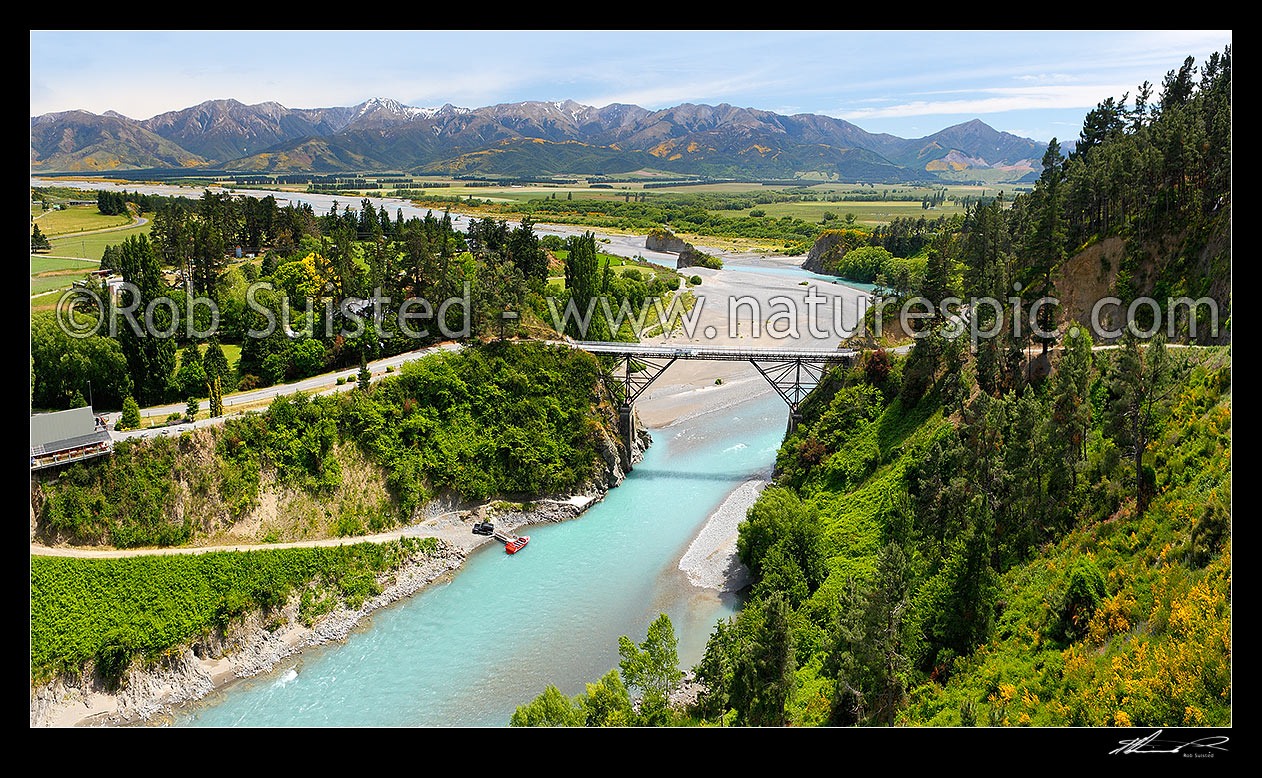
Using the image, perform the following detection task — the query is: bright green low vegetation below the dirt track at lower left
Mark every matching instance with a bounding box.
[30,538,438,690]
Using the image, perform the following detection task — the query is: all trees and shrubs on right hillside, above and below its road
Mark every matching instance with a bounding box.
[515,51,1232,726]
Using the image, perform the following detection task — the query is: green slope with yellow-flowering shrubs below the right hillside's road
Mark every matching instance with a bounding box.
[698,341,1230,725]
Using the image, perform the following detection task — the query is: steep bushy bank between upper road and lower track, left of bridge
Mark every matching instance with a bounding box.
[32,342,628,547]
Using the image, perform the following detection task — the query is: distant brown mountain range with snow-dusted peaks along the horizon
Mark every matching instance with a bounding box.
[30,99,1044,183]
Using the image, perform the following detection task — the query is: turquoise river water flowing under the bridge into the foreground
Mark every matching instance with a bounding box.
[173,390,786,726]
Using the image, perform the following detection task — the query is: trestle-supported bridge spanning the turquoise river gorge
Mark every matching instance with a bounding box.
[569,341,858,469]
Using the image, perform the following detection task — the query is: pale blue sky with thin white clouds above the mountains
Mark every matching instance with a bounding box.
[30,30,1232,140]
